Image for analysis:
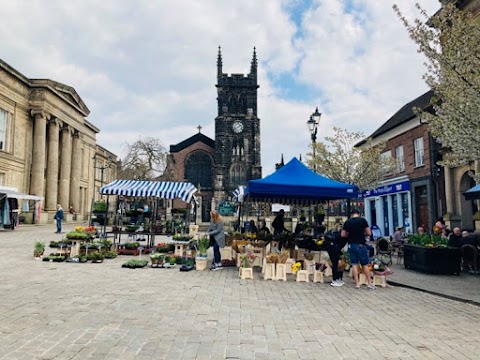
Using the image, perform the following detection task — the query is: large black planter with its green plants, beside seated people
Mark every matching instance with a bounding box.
[403,234,461,274]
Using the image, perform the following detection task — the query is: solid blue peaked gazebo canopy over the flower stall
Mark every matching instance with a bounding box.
[245,157,358,202]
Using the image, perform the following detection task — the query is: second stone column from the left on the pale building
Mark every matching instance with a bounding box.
[45,119,61,211]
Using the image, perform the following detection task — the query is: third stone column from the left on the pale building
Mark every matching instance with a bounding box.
[58,125,73,211]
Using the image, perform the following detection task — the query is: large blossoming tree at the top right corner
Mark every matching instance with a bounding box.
[394,1,480,181]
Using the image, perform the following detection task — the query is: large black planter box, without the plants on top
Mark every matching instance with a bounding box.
[403,244,461,274]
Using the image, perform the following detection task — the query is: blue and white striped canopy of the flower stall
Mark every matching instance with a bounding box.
[99,180,197,202]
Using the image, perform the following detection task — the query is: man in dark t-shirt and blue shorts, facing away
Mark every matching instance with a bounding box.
[341,209,375,290]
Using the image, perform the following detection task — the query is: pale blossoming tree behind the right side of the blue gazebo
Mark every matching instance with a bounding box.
[307,127,396,190]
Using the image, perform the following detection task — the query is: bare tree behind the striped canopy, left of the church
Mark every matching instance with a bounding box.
[118,137,170,180]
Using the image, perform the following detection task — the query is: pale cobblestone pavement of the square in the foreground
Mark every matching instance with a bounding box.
[0,225,480,360]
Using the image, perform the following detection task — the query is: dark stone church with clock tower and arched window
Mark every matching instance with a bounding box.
[169,48,262,221]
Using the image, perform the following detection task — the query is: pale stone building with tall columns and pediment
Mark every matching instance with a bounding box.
[0,60,116,223]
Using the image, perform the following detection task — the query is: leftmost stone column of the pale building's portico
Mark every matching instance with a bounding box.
[30,110,50,200]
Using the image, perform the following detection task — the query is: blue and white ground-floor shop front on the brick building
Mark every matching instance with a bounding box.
[360,176,413,236]
